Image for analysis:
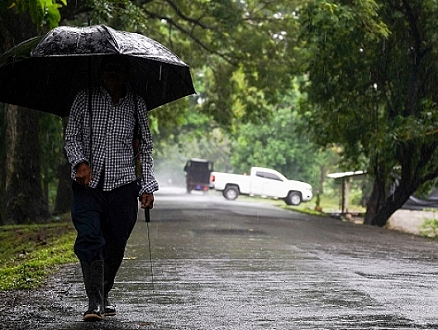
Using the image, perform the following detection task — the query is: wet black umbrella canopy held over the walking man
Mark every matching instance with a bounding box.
[0,25,195,117]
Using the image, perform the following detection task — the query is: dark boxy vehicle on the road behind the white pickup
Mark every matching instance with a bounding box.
[184,158,213,193]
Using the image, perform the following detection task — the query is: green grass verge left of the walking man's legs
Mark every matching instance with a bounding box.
[0,219,76,292]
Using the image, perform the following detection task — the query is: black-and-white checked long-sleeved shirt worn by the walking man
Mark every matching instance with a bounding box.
[64,87,158,196]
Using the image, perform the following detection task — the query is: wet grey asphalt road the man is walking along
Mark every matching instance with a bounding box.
[0,189,438,330]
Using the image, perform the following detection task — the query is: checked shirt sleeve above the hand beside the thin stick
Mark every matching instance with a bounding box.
[137,97,158,196]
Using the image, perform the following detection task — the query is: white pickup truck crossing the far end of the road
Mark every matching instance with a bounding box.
[210,167,313,205]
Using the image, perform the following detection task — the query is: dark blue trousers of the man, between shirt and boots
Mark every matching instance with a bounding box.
[72,181,138,264]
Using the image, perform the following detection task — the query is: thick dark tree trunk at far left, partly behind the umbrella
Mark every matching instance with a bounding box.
[0,3,48,224]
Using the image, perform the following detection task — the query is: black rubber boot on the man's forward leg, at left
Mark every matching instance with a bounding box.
[81,260,104,322]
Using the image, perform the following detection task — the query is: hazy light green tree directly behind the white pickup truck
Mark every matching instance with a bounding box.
[231,83,333,193]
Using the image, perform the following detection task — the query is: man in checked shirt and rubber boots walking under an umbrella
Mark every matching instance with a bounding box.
[65,56,158,321]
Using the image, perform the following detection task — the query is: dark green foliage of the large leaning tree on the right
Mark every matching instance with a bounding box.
[303,1,438,165]
